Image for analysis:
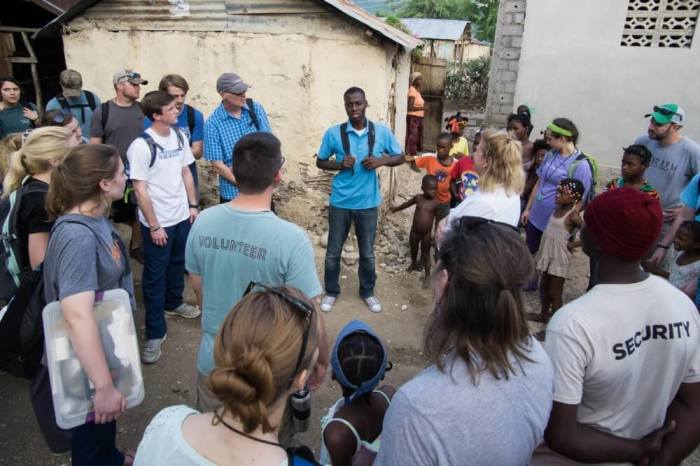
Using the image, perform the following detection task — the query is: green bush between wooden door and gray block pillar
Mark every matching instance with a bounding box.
[445,57,491,109]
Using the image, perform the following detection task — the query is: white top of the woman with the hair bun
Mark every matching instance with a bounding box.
[134,405,289,466]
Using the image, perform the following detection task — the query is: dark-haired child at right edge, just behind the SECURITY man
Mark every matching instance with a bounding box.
[645,220,700,299]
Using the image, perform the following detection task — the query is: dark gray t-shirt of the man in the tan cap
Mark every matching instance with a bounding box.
[90,100,143,161]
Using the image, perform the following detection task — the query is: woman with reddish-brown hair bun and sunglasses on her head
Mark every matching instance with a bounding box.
[134,282,319,466]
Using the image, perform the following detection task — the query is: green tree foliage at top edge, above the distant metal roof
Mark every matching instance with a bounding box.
[386,0,498,42]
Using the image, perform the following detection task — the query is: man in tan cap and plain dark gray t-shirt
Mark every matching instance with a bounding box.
[90,69,148,264]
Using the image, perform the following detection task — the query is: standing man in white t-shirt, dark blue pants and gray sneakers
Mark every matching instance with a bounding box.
[127,91,200,364]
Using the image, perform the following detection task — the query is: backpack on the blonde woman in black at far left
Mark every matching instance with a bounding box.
[0,177,48,303]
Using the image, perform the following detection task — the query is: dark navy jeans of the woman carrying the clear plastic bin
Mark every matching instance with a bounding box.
[71,422,124,466]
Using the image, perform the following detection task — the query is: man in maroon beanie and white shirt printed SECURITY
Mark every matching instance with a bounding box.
[530,189,700,465]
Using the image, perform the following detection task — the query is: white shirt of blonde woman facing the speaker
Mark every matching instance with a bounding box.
[445,186,520,231]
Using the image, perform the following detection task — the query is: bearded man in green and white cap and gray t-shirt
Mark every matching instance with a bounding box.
[635,104,700,269]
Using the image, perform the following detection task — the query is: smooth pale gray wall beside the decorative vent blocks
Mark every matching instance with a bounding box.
[513,0,700,166]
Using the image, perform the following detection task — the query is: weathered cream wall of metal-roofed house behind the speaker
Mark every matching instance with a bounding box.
[64,28,410,198]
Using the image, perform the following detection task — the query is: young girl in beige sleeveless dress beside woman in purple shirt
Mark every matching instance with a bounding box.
[535,178,585,322]
